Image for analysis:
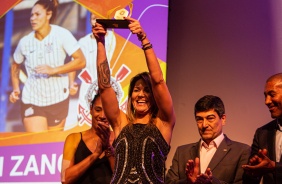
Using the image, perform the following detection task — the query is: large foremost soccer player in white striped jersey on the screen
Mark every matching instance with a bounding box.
[10,0,85,132]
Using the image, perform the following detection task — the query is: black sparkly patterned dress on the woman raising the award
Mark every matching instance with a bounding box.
[111,123,170,184]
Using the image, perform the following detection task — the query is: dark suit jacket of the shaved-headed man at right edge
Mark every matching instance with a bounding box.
[246,120,282,184]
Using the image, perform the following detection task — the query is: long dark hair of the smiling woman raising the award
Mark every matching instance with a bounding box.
[127,72,159,122]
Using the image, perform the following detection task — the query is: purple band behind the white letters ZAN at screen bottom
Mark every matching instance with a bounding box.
[0,142,64,182]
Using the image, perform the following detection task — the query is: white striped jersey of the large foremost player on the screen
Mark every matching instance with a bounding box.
[14,25,80,106]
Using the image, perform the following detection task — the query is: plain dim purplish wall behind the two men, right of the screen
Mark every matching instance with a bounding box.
[167,0,282,168]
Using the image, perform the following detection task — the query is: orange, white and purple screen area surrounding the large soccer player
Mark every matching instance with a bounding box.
[0,0,168,183]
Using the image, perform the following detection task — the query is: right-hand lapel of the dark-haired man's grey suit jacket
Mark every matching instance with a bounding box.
[208,135,232,170]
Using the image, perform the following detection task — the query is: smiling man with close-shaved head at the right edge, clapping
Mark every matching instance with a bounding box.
[243,73,282,184]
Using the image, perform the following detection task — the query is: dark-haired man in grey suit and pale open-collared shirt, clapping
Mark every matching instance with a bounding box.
[165,95,251,184]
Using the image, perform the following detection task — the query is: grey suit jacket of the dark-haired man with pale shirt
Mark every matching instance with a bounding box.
[165,135,251,184]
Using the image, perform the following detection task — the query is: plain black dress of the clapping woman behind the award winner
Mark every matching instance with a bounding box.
[74,135,112,184]
